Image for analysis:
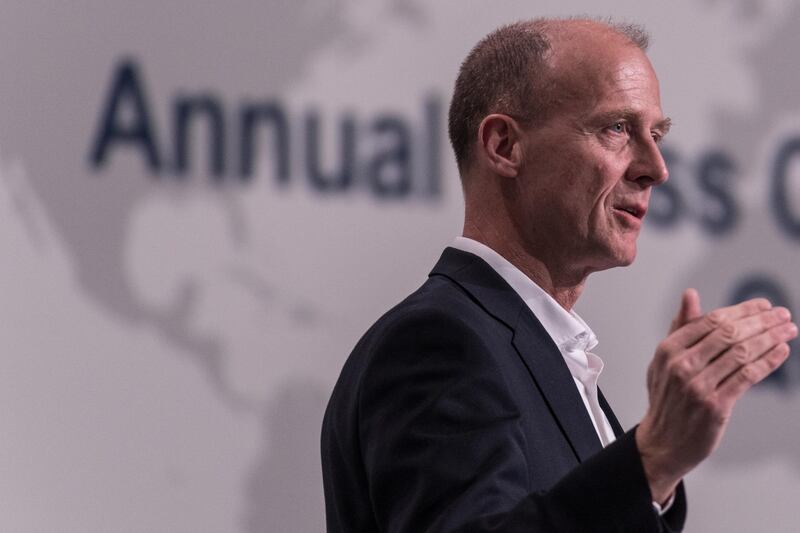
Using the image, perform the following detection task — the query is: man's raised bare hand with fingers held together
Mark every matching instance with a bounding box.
[636,289,797,502]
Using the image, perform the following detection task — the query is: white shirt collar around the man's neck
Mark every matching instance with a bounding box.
[451,237,597,352]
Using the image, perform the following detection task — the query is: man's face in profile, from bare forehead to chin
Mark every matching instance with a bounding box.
[512,34,669,275]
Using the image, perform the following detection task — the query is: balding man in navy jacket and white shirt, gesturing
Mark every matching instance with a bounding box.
[322,19,797,533]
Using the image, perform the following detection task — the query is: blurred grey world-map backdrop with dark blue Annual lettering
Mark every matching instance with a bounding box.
[0,0,800,533]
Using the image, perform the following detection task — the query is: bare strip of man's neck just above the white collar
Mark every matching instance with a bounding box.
[463,220,588,311]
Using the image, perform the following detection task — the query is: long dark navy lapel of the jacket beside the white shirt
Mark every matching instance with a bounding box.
[431,248,604,461]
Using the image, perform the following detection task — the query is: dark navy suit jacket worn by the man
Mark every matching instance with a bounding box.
[322,248,686,533]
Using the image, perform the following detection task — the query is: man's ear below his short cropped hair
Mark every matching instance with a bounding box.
[478,113,522,178]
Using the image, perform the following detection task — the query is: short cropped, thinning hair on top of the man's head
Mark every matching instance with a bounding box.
[448,18,649,179]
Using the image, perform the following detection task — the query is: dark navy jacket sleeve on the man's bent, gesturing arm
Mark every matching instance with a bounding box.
[357,311,685,533]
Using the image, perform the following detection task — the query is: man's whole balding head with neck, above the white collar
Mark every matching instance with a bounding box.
[450,19,670,294]
